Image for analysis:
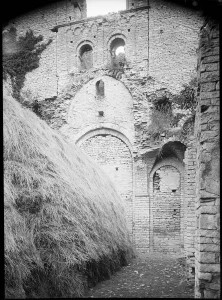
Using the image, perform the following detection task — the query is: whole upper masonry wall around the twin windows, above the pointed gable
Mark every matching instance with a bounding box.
[3,0,202,100]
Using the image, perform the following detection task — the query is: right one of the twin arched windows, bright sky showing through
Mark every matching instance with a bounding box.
[110,38,126,69]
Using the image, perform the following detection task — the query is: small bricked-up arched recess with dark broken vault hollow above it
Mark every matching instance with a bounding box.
[149,141,186,253]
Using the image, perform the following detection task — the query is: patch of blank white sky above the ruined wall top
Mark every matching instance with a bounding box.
[86,0,126,17]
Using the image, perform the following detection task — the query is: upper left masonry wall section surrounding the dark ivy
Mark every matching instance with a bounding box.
[3,0,86,100]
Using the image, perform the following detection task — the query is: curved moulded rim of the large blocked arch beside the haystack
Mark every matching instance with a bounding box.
[76,126,133,157]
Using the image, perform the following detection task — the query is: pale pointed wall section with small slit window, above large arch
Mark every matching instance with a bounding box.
[61,76,134,144]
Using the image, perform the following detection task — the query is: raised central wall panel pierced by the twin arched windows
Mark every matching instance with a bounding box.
[57,5,148,91]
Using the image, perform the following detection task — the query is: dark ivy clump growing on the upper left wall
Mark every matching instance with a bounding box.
[3,28,52,101]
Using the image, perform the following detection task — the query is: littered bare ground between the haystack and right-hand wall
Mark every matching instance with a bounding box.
[84,254,194,298]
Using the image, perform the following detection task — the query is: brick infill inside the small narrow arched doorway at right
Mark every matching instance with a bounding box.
[151,165,181,252]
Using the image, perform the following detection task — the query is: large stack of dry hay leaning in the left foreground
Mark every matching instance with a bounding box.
[3,95,132,298]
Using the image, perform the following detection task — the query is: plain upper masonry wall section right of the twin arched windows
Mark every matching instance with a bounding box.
[149,0,203,93]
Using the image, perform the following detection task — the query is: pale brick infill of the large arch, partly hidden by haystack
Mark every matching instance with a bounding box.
[79,133,133,234]
